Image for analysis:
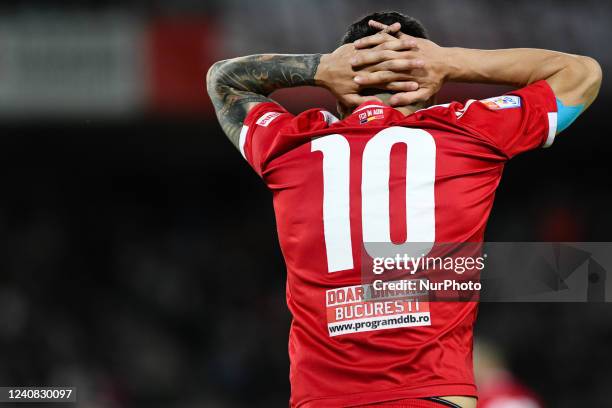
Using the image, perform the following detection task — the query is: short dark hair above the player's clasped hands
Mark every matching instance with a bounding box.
[342,11,429,44]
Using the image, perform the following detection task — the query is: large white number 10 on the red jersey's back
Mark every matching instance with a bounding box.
[311,127,436,272]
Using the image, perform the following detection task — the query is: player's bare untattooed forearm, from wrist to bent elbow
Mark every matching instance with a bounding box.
[446,48,601,107]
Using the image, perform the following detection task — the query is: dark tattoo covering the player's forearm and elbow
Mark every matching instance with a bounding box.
[206,54,321,147]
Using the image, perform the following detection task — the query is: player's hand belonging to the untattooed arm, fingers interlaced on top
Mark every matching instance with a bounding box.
[351,20,447,106]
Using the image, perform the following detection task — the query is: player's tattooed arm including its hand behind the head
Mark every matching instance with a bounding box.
[206,39,418,147]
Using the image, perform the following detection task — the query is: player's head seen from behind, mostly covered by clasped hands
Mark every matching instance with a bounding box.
[338,11,429,116]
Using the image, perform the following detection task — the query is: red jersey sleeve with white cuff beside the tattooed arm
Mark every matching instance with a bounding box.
[239,102,294,176]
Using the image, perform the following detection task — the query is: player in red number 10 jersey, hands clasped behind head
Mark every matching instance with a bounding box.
[207,12,601,408]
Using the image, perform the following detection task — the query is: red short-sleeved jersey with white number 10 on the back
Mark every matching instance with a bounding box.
[240,81,556,407]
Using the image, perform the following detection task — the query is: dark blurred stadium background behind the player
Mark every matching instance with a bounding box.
[0,0,612,408]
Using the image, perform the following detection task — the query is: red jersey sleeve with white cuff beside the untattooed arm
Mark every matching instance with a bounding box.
[455,81,557,158]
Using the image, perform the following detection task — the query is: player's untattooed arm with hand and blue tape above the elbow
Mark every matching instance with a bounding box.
[352,22,602,131]
